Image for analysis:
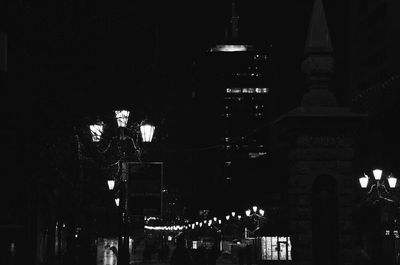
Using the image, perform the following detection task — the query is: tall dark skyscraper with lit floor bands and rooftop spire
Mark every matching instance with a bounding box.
[193,1,273,212]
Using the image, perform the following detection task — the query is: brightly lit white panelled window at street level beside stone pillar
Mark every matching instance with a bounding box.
[261,236,292,260]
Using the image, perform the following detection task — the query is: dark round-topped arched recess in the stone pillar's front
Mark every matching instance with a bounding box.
[312,174,339,265]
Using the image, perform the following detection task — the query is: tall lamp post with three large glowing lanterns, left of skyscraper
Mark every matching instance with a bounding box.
[89,110,155,265]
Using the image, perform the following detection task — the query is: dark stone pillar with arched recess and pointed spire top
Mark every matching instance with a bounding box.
[273,0,365,265]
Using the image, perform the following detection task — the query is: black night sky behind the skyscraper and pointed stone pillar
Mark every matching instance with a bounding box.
[1,0,347,217]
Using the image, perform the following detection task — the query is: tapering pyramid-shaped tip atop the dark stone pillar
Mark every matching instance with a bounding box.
[304,0,333,53]
